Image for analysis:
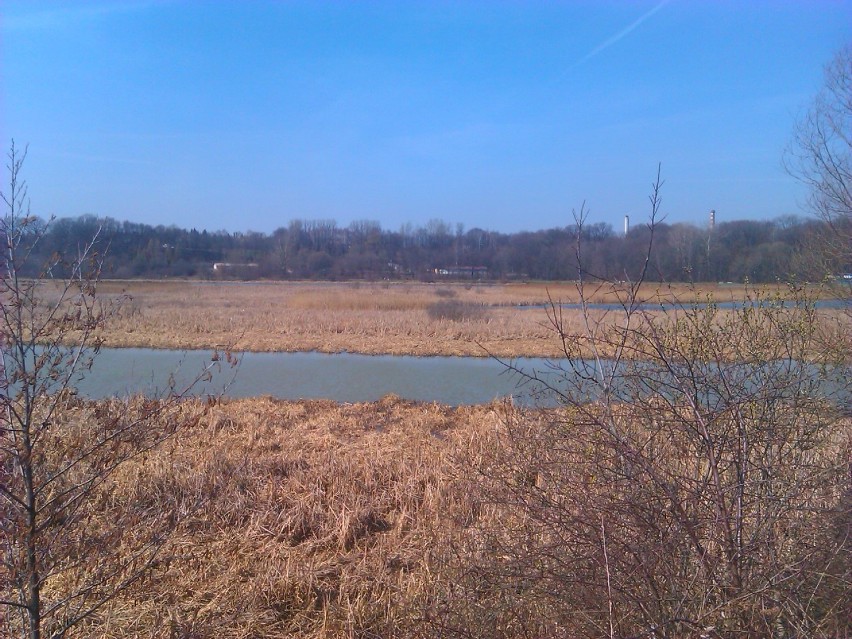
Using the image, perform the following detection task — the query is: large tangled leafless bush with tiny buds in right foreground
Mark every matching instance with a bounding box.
[432,172,852,638]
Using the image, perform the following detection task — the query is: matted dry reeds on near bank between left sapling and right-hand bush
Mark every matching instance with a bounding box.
[70,397,504,639]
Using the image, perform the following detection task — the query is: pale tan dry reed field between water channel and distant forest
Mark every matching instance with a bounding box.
[78,281,840,357]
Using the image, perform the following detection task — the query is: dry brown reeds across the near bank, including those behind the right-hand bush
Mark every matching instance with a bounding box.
[10,397,849,639]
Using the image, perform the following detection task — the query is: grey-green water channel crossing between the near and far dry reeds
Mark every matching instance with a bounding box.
[48,348,852,407]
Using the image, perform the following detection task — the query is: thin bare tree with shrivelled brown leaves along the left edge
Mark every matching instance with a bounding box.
[0,143,226,639]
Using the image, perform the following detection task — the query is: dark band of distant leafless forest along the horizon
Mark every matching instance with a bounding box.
[16,216,852,282]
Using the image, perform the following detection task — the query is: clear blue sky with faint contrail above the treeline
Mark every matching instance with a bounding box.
[0,0,852,232]
